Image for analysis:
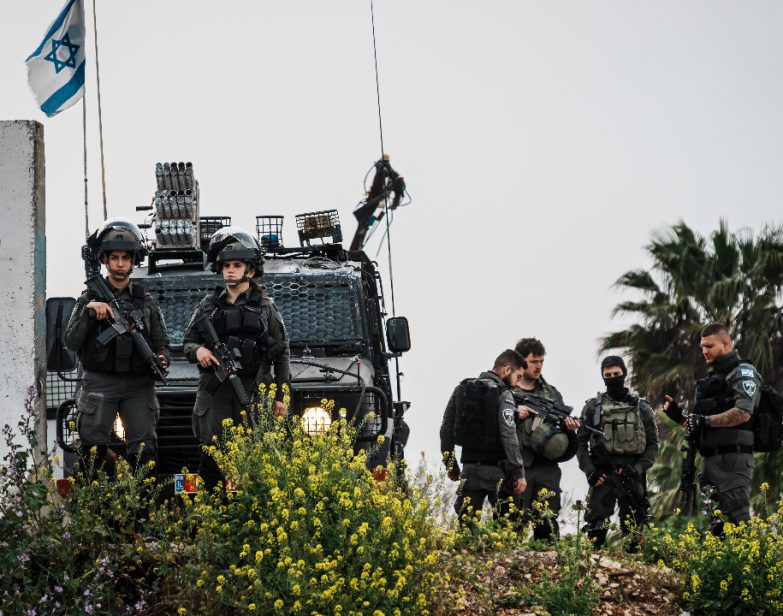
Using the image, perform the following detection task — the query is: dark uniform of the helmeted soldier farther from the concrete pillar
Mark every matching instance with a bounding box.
[182,283,290,488]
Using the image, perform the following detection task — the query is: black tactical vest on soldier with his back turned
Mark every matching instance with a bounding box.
[454,379,505,462]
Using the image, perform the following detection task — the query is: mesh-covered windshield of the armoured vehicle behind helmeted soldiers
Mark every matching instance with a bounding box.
[144,272,363,348]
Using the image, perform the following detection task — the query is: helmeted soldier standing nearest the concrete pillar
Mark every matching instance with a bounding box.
[65,218,169,472]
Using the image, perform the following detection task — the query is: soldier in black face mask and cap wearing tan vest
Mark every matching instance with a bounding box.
[577,355,658,552]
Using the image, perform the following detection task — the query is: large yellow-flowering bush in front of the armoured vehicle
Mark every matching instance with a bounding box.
[163,391,448,615]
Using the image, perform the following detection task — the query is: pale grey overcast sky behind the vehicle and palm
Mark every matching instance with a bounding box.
[0,0,783,496]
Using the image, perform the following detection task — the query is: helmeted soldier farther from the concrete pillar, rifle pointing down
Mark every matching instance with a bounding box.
[183,227,290,490]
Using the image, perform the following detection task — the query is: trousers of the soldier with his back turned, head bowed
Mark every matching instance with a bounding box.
[454,462,513,523]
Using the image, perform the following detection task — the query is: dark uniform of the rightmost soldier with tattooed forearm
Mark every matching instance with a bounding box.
[693,351,761,522]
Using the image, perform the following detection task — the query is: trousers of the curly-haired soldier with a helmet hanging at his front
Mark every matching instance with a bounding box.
[519,462,562,540]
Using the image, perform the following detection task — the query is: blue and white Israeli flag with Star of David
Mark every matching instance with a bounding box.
[26,0,85,117]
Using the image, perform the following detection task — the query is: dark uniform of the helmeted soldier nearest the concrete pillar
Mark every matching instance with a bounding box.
[65,280,169,463]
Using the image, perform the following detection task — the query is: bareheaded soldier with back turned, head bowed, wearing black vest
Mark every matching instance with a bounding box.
[440,349,525,522]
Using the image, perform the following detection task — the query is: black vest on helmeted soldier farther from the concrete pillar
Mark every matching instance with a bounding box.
[210,287,270,376]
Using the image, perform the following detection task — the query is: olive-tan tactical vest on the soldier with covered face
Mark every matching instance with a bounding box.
[590,393,647,456]
